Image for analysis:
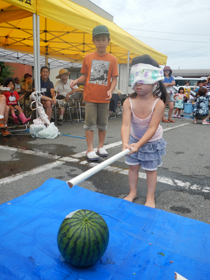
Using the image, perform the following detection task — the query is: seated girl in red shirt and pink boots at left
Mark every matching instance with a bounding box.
[4,78,31,124]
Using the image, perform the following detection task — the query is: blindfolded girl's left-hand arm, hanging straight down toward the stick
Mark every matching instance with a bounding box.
[121,98,131,150]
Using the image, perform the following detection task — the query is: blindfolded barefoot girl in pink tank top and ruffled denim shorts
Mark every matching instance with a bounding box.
[121,55,167,207]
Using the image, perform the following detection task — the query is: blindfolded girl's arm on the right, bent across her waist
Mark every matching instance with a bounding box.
[129,100,165,154]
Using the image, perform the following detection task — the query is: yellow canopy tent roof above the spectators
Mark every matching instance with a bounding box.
[0,0,167,65]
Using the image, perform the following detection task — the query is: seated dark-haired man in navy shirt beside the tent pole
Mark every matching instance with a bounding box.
[33,66,56,121]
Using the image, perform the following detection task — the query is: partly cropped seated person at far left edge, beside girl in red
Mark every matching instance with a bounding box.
[0,94,11,137]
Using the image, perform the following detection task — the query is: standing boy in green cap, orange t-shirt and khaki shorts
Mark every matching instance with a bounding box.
[70,25,118,161]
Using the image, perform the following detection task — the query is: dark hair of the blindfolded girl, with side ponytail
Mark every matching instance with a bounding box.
[130,54,167,103]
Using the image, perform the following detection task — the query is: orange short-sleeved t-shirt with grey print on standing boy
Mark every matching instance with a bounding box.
[81,52,118,103]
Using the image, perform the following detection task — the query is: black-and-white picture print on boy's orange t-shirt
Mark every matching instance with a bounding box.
[89,60,110,86]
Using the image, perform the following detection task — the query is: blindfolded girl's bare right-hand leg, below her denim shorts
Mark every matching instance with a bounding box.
[145,170,157,208]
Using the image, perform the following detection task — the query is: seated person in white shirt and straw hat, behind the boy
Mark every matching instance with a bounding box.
[55,69,83,125]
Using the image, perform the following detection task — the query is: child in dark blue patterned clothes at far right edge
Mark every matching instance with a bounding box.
[193,88,210,124]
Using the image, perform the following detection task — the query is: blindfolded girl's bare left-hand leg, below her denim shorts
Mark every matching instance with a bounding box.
[124,164,140,202]
